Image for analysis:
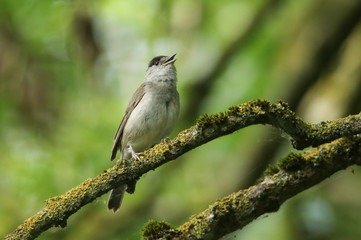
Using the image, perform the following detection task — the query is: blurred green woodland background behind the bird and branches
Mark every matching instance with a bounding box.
[0,0,361,240]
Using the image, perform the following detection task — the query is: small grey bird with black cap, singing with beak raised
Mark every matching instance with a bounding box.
[108,54,180,213]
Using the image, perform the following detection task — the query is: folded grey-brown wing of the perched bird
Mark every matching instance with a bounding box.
[110,83,145,160]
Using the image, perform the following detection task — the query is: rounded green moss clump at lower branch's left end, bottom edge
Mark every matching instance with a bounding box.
[142,220,176,240]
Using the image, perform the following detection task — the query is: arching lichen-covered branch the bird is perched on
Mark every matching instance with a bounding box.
[5,100,361,239]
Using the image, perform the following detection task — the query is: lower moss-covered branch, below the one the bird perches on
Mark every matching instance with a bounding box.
[143,135,361,240]
